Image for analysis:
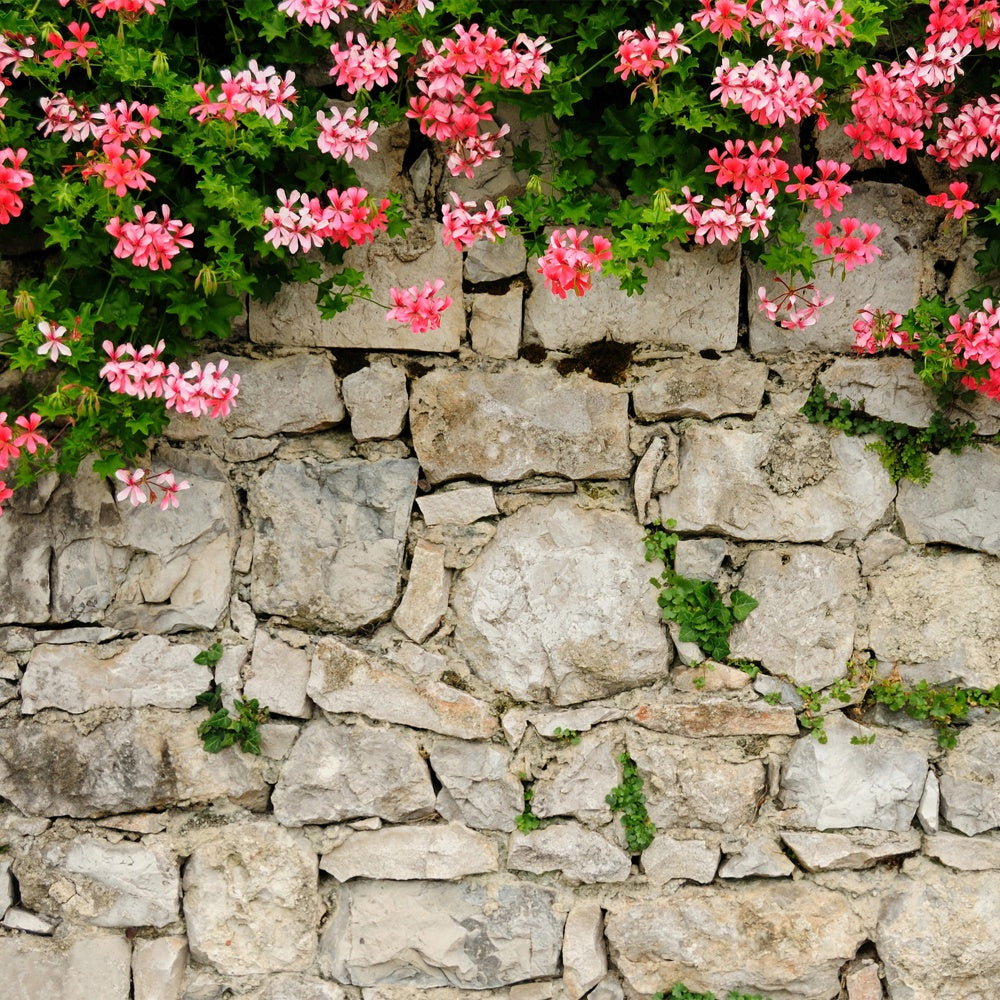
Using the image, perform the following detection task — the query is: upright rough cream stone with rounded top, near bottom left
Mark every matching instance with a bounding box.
[184,822,319,976]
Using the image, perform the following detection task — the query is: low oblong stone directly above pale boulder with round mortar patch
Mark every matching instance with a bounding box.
[632,355,767,423]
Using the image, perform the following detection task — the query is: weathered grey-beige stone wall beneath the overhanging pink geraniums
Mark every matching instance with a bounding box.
[0,153,1000,1000]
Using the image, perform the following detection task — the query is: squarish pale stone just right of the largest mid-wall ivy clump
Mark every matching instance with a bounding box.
[729,545,861,690]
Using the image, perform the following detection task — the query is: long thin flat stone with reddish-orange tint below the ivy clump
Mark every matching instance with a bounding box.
[630,700,799,736]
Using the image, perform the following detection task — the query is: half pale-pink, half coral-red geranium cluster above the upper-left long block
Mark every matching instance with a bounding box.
[263,187,390,253]
